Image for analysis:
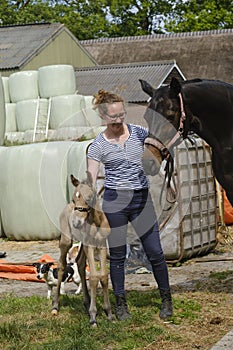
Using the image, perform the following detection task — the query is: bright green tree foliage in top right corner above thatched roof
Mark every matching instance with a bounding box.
[165,0,233,33]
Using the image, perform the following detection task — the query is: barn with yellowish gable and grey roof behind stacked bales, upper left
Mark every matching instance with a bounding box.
[0,23,97,76]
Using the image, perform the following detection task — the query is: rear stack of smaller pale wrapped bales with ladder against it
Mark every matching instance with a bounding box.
[3,65,101,144]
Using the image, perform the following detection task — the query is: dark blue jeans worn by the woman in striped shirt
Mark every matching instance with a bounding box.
[103,188,170,295]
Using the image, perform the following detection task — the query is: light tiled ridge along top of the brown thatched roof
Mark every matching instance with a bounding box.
[80,28,233,44]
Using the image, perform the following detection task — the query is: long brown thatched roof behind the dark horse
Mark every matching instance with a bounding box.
[80,29,233,84]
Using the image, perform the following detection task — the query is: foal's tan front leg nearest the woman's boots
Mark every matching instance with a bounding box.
[99,248,113,321]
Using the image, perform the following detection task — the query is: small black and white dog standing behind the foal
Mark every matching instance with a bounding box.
[33,262,82,299]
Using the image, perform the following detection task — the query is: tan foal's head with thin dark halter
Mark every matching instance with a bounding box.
[70,172,96,229]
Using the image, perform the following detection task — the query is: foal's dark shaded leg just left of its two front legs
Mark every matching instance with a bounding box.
[76,244,90,313]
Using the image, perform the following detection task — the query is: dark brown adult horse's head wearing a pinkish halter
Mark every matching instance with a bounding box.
[140,78,181,175]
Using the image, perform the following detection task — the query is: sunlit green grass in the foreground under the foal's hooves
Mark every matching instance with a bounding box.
[0,291,201,350]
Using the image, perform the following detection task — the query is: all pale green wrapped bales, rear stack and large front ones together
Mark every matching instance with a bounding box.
[0,65,102,240]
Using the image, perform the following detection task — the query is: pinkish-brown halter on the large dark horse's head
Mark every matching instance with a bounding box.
[145,93,186,160]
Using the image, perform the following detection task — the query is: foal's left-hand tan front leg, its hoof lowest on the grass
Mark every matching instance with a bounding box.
[87,246,99,326]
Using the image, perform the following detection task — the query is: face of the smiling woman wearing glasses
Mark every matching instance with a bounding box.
[102,102,126,129]
